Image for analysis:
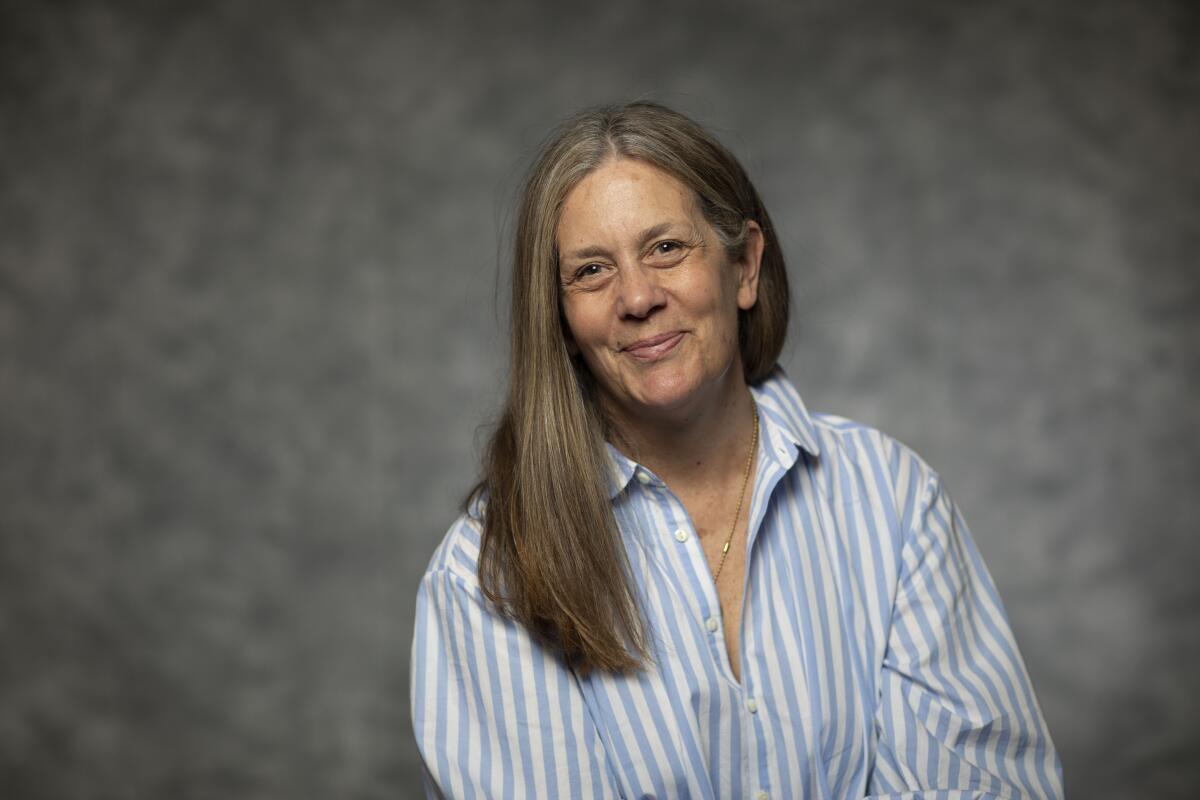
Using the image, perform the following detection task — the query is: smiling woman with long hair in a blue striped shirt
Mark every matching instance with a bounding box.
[412,103,1062,799]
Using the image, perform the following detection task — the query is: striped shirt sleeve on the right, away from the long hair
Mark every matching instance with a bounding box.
[868,468,1062,800]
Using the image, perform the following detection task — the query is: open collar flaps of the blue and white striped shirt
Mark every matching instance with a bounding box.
[606,366,821,499]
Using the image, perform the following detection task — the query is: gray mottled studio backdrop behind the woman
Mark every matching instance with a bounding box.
[0,0,1200,800]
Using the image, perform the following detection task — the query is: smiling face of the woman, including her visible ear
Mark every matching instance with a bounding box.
[557,158,762,429]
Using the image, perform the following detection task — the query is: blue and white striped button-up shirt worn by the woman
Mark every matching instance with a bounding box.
[412,371,1062,800]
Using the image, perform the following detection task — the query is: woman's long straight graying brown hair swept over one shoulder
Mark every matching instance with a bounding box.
[467,102,788,673]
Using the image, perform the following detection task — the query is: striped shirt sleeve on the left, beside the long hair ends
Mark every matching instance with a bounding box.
[412,569,617,798]
